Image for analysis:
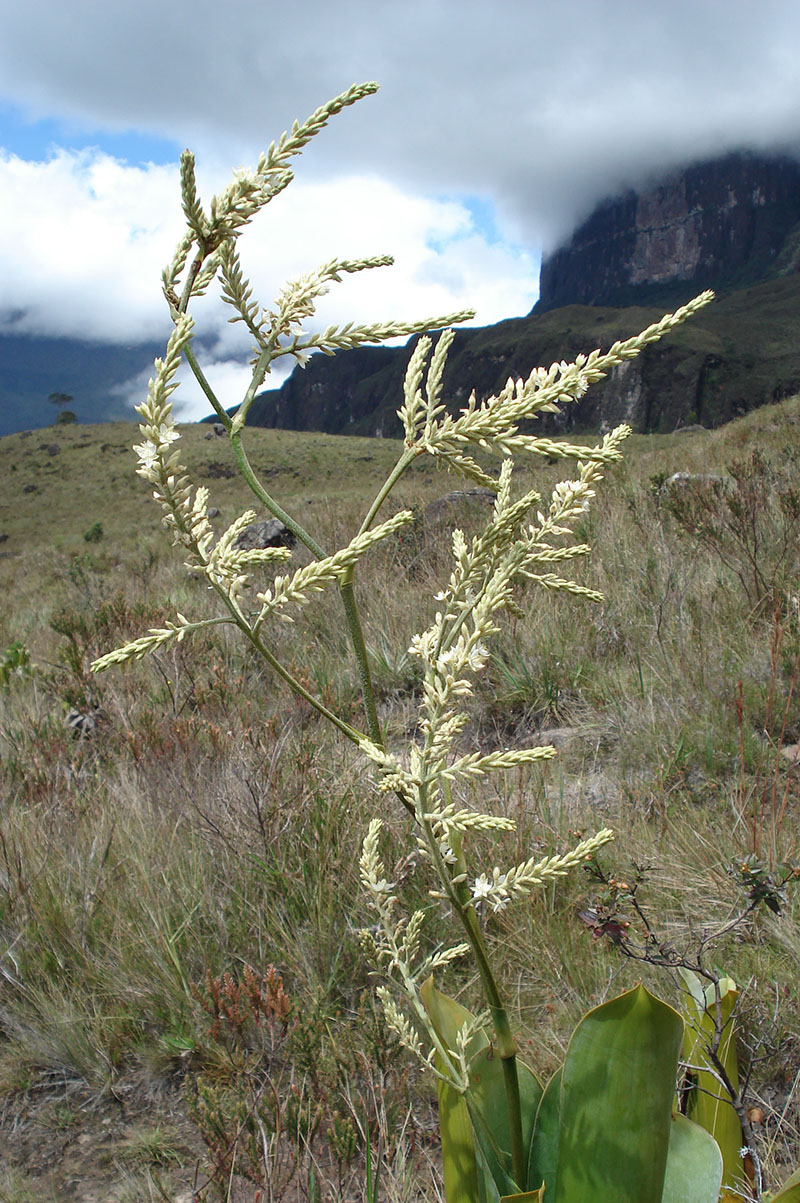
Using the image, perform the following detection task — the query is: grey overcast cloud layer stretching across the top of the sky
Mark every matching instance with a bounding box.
[0,0,800,250]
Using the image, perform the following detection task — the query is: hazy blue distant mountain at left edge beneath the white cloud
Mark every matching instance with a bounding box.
[0,333,164,434]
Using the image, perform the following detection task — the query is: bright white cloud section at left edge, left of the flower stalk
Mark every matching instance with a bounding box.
[0,152,182,342]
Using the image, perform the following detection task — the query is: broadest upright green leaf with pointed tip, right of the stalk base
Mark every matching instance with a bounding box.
[555,985,683,1203]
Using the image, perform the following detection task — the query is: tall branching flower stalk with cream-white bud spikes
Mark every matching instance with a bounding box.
[93,83,711,1183]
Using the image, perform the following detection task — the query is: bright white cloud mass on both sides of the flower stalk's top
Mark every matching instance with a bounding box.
[79,163,538,421]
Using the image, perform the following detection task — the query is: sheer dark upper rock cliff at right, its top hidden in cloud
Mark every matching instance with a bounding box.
[535,154,800,313]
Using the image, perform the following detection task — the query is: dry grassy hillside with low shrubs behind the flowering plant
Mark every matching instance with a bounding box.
[0,398,800,1203]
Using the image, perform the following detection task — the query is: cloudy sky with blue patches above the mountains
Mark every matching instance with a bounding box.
[0,0,800,419]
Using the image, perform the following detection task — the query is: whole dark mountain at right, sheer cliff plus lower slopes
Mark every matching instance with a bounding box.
[243,147,800,437]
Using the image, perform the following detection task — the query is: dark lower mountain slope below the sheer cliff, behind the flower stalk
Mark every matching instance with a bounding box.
[243,275,800,437]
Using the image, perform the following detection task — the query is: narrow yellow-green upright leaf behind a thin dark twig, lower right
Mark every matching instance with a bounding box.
[680,970,745,1187]
